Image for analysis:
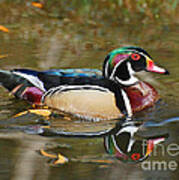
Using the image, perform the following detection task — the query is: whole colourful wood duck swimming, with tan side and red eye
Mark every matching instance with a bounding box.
[0,47,169,120]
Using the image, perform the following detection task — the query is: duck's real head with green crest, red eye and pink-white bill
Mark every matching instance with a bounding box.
[103,47,169,86]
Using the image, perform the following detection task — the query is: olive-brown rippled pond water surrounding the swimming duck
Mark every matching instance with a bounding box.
[0,2,179,180]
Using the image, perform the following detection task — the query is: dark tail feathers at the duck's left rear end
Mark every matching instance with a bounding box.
[0,70,32,97]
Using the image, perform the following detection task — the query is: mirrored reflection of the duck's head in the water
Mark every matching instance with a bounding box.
[104,122,168,163]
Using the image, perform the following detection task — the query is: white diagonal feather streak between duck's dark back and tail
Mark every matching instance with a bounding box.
[13,71,46,91]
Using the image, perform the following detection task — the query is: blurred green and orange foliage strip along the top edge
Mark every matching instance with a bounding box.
[0,0,178,23]
